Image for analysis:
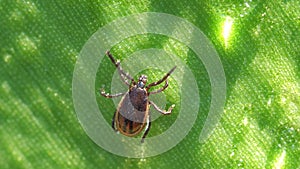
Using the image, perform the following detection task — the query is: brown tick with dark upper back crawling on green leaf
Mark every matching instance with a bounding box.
[101,51,176,143]
